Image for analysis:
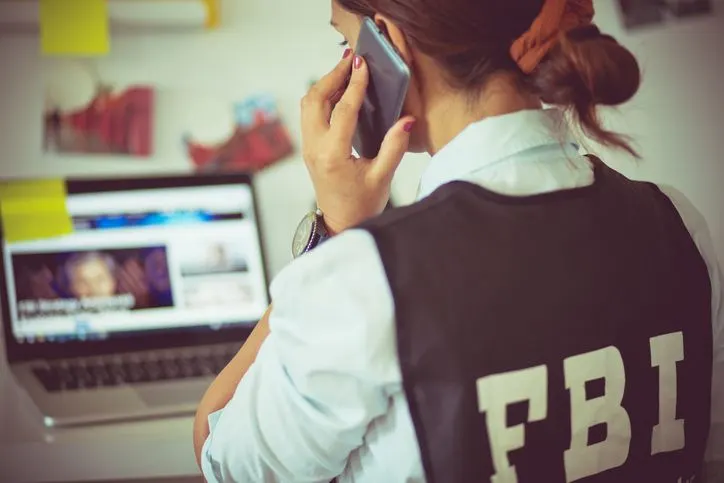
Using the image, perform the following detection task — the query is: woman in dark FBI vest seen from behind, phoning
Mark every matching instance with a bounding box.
[195,0,724,482]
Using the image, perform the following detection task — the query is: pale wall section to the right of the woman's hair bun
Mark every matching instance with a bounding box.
[595,0,724,261]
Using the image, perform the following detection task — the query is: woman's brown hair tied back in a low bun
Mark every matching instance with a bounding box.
[336,0,641,157]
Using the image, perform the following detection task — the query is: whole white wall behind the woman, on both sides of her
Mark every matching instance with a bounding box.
[0,0,724,280]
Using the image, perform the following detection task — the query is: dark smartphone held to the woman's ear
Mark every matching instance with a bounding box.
[352,17,410,159]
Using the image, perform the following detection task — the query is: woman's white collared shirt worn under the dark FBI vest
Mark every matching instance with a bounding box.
[202,110,724,483]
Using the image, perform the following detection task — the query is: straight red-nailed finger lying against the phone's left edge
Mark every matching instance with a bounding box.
[329,56,369,144]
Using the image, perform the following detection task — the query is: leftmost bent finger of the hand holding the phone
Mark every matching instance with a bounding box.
[302,49,353,135]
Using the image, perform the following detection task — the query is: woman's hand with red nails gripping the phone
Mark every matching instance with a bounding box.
[302,50,415,233]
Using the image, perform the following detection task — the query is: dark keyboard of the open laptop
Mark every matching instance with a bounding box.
[32,346,239,392]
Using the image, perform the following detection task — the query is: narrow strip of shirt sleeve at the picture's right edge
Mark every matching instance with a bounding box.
[661,186,724,468]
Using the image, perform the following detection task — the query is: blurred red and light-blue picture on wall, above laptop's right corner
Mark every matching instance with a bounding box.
[183,94,294,173]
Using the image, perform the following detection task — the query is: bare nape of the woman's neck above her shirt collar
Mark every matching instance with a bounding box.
[427,74,542,155]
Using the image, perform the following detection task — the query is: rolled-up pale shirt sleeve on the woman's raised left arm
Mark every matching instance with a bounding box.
[202,231,401,483]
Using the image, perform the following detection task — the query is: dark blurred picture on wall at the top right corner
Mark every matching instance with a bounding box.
[617,0,712,30]
